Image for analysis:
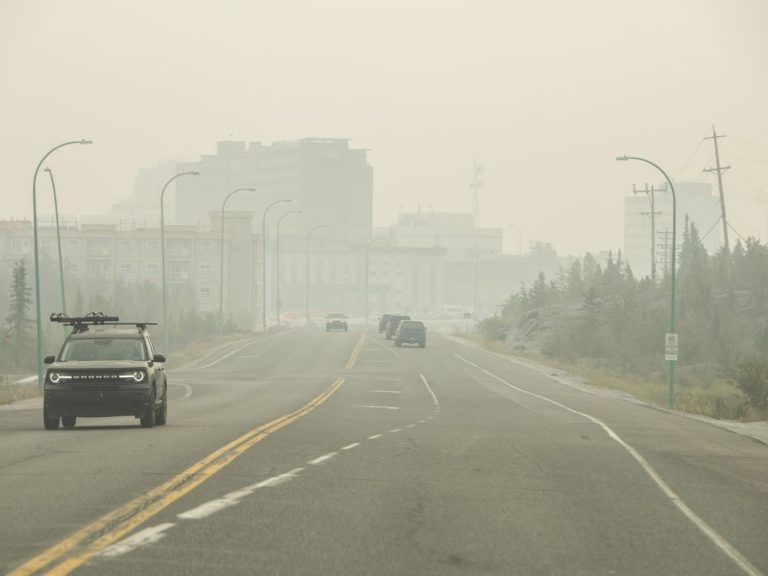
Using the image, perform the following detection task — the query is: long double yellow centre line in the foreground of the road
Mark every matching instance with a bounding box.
[9,378,344,576]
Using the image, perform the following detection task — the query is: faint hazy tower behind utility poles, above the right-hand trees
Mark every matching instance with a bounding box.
[623,182,722,278]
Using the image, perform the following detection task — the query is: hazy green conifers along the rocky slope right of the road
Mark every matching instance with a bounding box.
[480,222,768,410]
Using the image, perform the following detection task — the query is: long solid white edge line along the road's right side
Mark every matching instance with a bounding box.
[453,352,762,576]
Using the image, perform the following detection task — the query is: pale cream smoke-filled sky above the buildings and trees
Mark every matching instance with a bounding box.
[0,0,768,253]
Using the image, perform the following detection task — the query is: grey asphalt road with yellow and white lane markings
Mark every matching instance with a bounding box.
[0,329,768,576]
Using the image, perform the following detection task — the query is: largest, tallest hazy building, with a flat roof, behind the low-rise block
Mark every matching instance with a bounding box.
[175,138,373,242]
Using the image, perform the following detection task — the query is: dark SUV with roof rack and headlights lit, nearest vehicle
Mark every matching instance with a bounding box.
[43,313,168,430]
